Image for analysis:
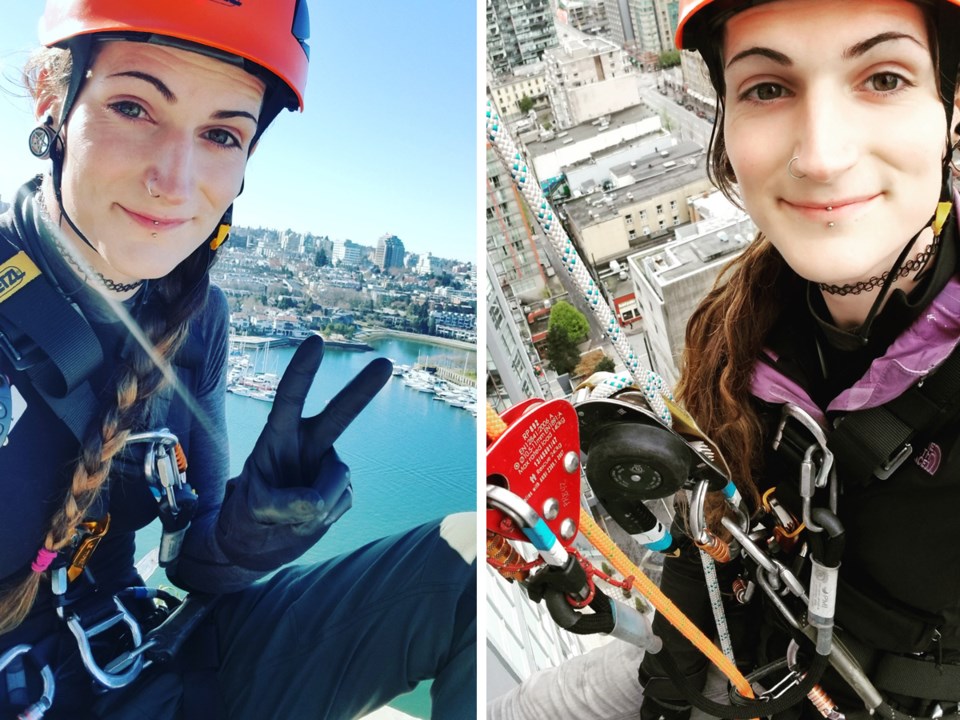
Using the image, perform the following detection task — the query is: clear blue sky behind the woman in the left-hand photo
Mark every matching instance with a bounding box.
[0,0,479,260]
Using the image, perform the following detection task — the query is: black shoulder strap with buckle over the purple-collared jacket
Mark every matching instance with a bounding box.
[827,350,960,485]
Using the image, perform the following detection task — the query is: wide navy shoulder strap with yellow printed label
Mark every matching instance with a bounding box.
[0,218,103,440]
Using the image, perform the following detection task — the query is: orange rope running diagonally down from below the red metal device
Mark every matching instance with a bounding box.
[580,508,754,698]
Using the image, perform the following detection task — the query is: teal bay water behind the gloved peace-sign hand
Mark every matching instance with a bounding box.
[139,338,477,718]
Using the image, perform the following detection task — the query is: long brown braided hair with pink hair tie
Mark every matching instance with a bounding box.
[0,50,210,633]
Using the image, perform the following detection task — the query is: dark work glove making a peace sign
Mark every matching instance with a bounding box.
[218,336,392,570]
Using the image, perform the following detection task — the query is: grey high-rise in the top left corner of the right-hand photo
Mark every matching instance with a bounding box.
[487,0,557,75]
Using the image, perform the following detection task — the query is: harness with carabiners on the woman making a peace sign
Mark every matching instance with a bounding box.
[0,198,208,720]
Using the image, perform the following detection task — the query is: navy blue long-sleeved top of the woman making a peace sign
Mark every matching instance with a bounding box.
[0,180,322,653]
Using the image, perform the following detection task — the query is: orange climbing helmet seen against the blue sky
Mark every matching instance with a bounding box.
[39,0,310,110]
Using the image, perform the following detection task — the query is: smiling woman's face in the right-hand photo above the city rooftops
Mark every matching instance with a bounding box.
[723,0,946,284]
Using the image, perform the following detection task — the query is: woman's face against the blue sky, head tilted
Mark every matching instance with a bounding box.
[54,41,264,280]
